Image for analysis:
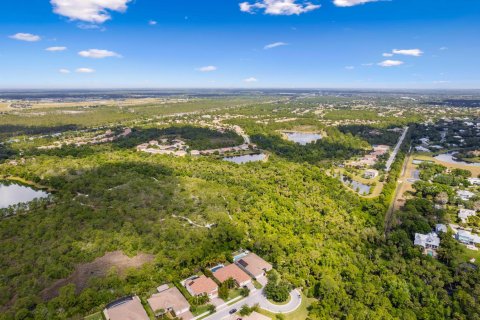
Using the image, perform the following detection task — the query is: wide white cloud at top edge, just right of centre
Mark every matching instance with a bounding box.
[240,0,320,16]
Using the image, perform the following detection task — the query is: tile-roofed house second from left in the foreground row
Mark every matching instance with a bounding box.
[147,287,190,318]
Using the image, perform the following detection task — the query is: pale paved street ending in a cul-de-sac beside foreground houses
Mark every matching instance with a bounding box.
[204,289,302,320]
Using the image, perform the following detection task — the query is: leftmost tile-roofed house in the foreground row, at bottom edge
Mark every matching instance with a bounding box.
[103,296,150,320]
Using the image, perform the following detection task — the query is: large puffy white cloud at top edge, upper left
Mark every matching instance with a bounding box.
[50,0,131,23]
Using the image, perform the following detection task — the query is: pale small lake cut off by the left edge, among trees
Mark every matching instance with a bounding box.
[0,181,48,209]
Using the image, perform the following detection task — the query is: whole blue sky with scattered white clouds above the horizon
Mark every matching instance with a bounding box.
[0,0,480,89]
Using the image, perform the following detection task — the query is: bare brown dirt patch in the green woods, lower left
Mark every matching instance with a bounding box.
[41,251,154,300]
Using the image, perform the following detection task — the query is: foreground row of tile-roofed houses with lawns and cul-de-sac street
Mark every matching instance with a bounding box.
[86,250,302,320]
